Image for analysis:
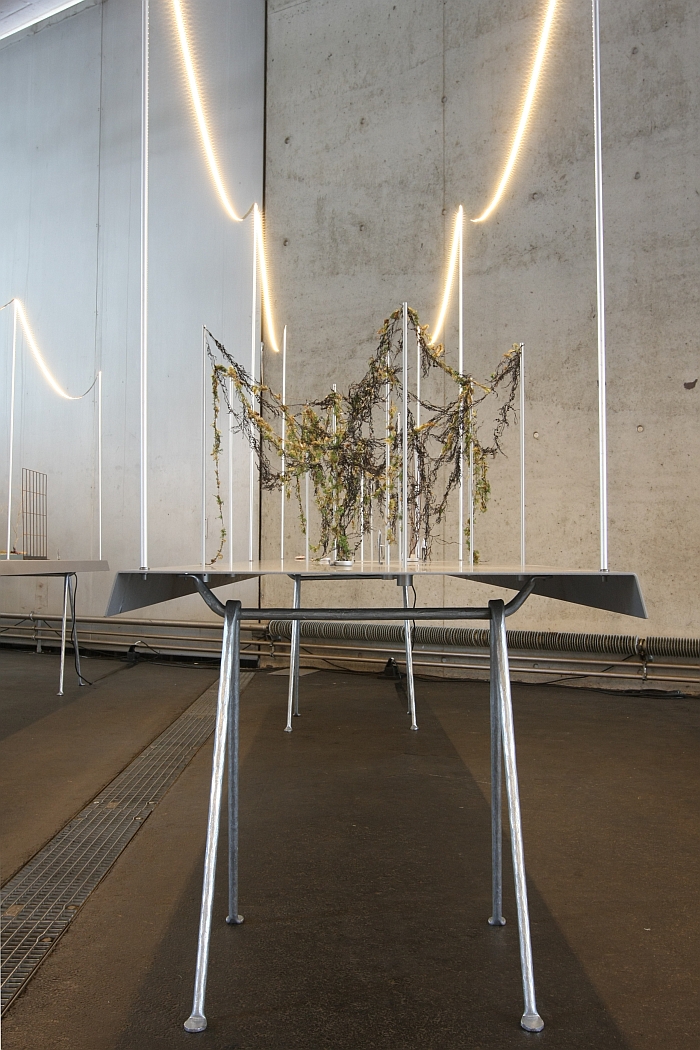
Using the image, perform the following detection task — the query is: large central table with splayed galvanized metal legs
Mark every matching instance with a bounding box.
[106,560,646,1032]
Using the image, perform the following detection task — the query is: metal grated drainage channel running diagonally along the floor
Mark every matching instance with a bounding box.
[0,673,254,1013]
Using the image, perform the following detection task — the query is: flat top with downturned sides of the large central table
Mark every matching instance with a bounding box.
[106,559,646,617]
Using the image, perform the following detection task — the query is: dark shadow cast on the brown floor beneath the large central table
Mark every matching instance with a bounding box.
[115,673,628,1050]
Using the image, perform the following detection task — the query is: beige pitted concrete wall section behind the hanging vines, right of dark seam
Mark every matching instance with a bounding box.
[266,0,700,634]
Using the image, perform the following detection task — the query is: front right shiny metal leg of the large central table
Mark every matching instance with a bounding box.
[489,600,545,1032]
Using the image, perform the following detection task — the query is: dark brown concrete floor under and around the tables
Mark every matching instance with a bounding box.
[0,653,700,1050]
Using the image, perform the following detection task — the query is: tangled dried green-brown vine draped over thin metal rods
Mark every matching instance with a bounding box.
[207,309,521,563]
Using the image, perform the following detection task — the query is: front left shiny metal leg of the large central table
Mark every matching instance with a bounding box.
[185,602,240,1032]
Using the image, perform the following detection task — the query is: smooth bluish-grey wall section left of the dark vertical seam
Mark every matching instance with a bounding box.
[0,0,264,617]
